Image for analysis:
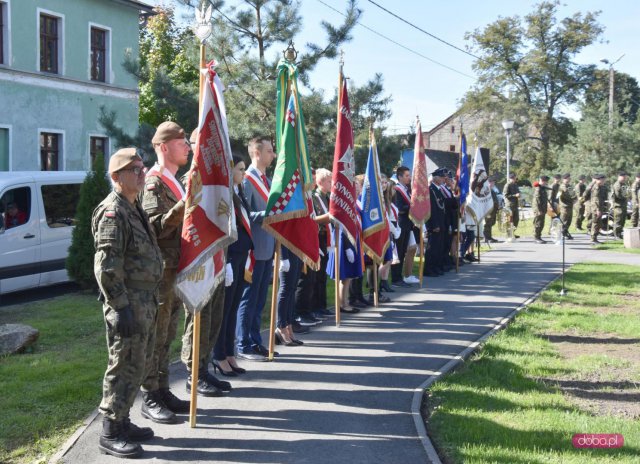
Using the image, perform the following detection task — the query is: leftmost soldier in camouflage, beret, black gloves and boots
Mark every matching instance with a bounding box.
[91,148,163,458]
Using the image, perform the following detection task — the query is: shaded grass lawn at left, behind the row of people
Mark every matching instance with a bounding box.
[0,268,334,464]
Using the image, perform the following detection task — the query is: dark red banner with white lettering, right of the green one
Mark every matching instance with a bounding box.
[329,75,359,246]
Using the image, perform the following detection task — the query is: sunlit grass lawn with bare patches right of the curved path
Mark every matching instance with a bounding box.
[426,264,640,464]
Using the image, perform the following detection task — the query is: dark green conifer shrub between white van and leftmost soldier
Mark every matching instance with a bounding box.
[65,153,111,288]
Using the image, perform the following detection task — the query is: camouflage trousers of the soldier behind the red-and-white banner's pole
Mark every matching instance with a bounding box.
[180,282,224,373]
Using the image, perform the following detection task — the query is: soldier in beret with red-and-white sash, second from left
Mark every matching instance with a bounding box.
[141,121,191,424]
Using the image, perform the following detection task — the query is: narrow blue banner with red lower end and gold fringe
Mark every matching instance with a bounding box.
[360,132,389,262]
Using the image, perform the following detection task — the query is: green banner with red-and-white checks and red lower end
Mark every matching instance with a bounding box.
[262,60,320,270]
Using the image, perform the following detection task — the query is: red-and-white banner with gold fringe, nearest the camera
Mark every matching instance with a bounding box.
[176,62,238,313]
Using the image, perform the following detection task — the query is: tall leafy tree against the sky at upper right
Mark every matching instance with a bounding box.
[463,0,603,176]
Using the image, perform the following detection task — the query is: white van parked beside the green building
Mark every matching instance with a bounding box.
[0,171,87,294]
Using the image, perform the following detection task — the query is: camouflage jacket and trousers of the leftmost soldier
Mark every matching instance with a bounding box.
[91,192,162,421]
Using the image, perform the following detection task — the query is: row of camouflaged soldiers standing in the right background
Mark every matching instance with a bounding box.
[504,172,640,244]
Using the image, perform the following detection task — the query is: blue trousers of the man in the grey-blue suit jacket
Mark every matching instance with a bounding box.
[236,259,273,354]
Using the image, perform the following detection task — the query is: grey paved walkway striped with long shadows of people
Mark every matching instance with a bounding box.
[62,235,640,464]
